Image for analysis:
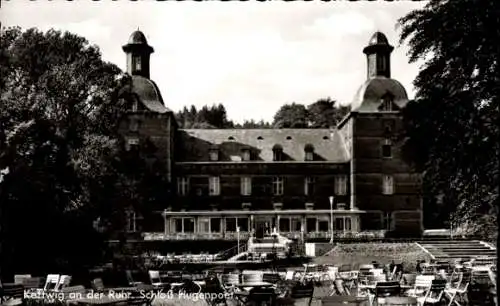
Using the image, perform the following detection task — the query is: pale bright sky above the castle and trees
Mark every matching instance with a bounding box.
[0,0,426,122]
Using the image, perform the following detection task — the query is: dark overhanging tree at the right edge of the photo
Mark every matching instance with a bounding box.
[399,0,500,237]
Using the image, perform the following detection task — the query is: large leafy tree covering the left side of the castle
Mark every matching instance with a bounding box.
[0,28,123,276]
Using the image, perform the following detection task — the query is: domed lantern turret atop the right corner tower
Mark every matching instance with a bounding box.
[363,32,394,79]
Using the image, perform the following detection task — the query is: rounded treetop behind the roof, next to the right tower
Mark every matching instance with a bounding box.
[307,98,350,128]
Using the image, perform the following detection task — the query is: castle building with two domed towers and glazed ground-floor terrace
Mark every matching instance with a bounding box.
[120,31,423,240]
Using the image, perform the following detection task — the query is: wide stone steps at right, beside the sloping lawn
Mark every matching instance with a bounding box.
[417,240,497,262]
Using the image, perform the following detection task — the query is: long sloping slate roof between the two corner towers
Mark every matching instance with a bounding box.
[177,129,349,163]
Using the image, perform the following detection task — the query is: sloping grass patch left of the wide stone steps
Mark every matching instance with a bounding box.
[314,242,431,270]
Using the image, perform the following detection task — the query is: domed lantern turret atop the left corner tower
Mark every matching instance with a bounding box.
[122,30,154,79]
